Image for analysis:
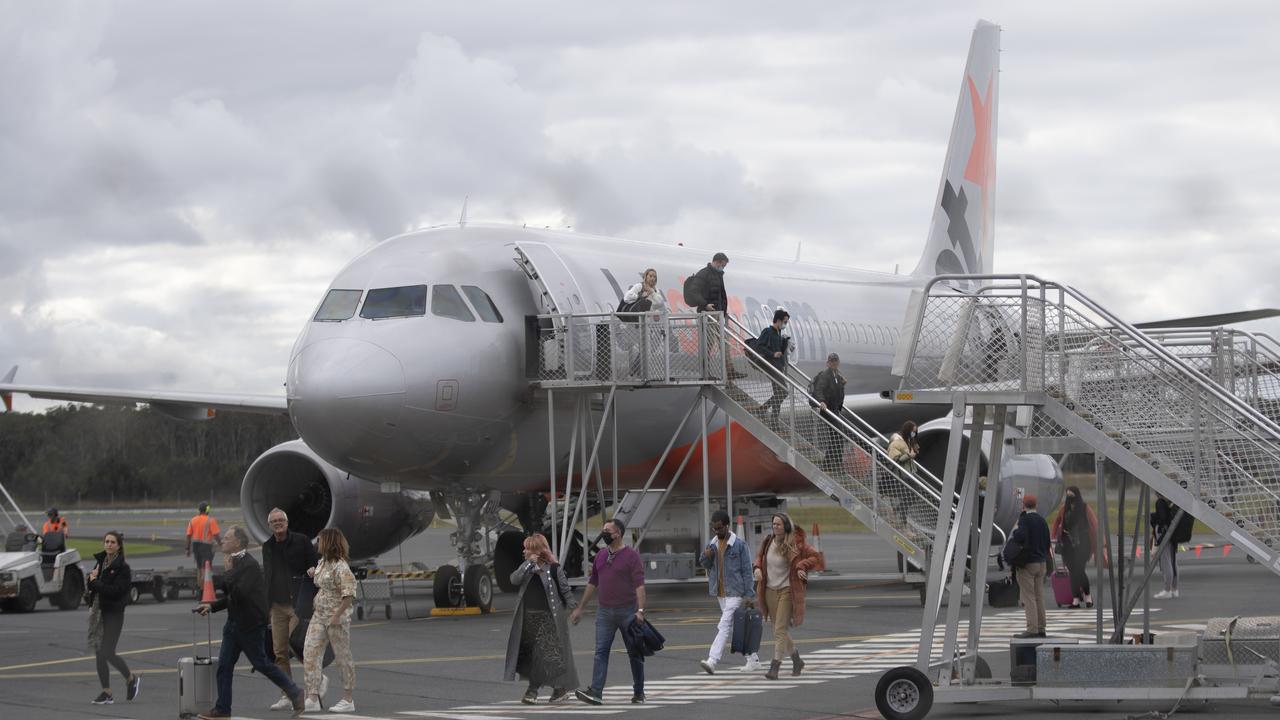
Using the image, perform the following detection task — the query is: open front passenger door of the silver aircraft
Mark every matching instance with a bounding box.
[515,242,596,375]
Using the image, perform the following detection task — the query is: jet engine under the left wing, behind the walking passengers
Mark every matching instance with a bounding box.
[241,439,435,560]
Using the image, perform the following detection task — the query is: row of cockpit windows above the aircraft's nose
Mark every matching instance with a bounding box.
[315,284,502,323]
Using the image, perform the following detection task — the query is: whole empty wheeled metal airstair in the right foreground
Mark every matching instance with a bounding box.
[877,275,1280,717]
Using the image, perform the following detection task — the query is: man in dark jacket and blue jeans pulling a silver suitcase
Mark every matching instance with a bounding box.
[196,525,306,720]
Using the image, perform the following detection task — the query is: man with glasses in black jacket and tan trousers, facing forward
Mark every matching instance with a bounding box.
[262,507,320,710]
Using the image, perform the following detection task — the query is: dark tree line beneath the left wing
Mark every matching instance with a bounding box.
[0,405,297,510]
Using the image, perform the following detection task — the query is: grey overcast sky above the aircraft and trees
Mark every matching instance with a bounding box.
[0,0,1280,410]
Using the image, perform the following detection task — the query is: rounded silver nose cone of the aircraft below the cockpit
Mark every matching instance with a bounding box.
[288,338,404,464]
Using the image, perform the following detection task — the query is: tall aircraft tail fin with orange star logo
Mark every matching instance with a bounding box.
[911,20,1000,277]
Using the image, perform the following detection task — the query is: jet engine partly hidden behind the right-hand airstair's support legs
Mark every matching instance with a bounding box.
[916,418,1065,533]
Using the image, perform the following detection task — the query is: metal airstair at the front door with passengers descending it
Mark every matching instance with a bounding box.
[529,313,1002,589]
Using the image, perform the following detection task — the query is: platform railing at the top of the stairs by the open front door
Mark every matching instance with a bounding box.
[527,313,726,387]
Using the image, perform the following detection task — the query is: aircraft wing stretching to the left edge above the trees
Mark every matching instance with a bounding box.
[0,368,289,420]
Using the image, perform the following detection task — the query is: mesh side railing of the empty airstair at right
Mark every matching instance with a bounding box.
[900,275,1280,546]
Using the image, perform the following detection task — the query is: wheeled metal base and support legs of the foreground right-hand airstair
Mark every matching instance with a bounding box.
[876,396,1280,720]
